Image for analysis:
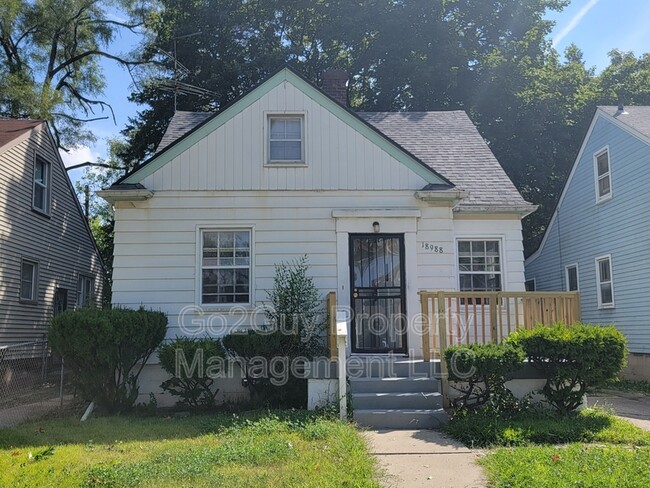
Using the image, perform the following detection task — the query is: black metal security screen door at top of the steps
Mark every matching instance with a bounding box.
[350,234,406,353]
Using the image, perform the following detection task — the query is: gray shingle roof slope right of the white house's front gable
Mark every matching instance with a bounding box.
[358,110,527,206]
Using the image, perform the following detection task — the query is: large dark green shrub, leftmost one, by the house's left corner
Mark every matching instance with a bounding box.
[48,308,167,412]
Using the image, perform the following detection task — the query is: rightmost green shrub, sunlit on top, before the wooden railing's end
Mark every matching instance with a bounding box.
[507,324,627,414]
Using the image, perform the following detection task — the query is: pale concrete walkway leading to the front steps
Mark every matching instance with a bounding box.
[364,430,487,488]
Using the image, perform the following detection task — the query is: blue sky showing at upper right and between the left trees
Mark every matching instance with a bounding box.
[63,0,650,179]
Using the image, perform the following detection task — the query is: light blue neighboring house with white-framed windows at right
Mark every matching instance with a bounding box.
[526,107,650,377]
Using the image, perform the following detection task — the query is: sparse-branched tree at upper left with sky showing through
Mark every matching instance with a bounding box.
[0,0,147,147]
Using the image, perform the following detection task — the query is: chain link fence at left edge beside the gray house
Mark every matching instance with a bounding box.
[0,339,72,428]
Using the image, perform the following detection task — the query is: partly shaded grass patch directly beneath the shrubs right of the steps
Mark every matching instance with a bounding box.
[447,409,650,447]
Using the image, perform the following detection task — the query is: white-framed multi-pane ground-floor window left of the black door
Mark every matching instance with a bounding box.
[201,230,251,305]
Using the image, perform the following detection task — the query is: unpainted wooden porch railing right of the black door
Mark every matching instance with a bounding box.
[419,291,580,362]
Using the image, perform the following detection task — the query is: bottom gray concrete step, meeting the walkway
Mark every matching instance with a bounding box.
[354,409,449,429]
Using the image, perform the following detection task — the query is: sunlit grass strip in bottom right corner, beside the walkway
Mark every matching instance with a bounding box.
[480,444,650,488]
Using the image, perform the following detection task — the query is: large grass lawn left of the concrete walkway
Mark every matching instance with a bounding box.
[0,412,379,487]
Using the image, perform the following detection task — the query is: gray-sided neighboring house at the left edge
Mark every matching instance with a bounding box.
[0,119,103,346]
